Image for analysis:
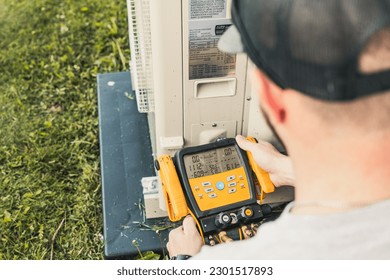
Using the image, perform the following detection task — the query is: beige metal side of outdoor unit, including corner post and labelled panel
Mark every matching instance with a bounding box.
[150,0,258,158]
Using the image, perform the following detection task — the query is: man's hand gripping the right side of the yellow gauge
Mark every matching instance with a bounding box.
[236,135,295,187]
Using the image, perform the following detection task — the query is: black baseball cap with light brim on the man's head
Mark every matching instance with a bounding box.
[218,0,390,101]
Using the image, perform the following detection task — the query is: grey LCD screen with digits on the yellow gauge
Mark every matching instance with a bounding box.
[183,146,242,179]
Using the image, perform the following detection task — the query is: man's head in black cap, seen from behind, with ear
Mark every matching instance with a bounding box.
[219,0,390,153]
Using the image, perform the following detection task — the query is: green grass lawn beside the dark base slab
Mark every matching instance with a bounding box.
[0,0,131,259]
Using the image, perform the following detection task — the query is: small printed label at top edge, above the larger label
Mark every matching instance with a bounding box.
[189,0,226,19]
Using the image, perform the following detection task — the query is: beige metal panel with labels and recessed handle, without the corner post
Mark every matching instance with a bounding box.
[182,0,249,145]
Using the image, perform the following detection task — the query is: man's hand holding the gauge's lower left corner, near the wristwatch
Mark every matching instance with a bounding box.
[167,216,203,257]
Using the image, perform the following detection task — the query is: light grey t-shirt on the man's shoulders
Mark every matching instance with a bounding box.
[192,200,390,260]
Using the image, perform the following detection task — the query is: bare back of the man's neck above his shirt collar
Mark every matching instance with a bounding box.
[290,131,390,213]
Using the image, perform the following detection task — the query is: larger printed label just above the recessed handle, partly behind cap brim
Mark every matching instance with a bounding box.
[189,18,236,80]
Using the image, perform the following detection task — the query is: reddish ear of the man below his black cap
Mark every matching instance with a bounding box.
[253,69,286,123]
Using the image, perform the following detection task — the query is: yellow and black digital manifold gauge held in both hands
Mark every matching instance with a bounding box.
[155,137,274,243]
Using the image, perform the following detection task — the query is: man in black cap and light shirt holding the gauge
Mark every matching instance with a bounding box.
[167,0,390,259]
